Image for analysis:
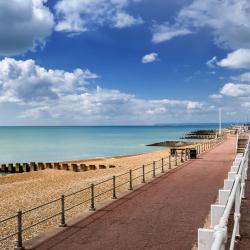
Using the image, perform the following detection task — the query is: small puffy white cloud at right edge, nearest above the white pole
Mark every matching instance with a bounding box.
[220,83,250,97]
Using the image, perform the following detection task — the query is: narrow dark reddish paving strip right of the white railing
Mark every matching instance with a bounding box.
[235,163,250,250]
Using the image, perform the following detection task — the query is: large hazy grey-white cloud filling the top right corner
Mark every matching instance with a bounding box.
[153,0,250,49]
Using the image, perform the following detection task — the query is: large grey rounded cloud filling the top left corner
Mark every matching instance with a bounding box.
[0,0,54,55]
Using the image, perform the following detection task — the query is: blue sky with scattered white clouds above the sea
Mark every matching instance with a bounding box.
[0,0,250,125]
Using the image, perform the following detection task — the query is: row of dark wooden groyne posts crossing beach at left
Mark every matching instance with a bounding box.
[0,162,116,174]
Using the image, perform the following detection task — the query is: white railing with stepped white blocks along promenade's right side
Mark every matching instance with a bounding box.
[198,132,250,250]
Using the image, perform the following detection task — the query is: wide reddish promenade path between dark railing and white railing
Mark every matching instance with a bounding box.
[32,137,235,250]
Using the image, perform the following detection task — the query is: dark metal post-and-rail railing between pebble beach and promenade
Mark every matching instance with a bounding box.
[0,137,224,249]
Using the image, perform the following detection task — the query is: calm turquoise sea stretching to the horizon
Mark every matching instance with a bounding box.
[0,124,228,163]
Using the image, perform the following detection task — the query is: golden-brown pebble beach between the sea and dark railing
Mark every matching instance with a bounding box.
[0,147,182,249]
